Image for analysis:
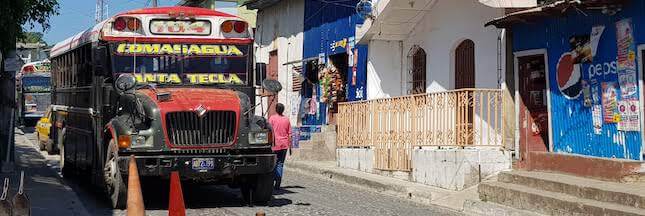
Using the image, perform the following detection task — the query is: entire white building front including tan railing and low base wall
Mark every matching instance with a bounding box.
[337,0,535,190]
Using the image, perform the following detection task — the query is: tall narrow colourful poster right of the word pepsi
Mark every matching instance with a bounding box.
[616,19,638,100]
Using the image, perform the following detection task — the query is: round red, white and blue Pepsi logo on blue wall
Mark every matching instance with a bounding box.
[556,52,582,99]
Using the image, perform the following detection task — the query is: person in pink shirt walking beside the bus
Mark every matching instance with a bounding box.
[269,103,291,190]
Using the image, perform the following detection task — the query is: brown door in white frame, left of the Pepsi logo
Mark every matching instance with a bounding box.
[516,54,549,160]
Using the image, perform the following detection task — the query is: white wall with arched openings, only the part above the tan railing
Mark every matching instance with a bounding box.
[358,0,506,99]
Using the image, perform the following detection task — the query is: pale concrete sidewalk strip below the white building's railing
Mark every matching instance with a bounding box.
[285,160,536,215]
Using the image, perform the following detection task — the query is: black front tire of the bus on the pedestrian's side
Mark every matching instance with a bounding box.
[240,172,273,205]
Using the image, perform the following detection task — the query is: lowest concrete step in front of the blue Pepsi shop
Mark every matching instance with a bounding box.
[478,181,645,216]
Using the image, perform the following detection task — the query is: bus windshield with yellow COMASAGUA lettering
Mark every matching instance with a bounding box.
[112,43,249,85]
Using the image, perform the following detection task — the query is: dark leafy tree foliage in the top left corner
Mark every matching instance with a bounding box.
[0,0,59,52]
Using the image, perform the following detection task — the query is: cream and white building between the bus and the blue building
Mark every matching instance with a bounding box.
[247,0,305,125]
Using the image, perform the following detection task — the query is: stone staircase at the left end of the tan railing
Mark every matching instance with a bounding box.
[288,125,336,161]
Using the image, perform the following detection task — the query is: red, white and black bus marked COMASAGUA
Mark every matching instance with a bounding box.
[51,7,279,208]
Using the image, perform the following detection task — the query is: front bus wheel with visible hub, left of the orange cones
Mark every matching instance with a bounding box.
[103,139,127,209]
